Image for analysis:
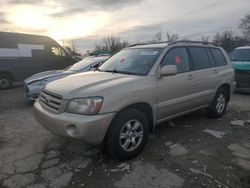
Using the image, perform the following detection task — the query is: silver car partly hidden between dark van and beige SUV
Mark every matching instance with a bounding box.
[24,56,109,102]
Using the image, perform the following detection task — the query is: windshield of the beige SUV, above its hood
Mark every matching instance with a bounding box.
[99,48,162,75]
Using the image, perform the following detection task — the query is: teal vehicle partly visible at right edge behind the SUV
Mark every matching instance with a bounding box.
[230,46,250,92]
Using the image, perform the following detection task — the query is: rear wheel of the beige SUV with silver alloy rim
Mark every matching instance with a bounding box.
[207,88,229,118]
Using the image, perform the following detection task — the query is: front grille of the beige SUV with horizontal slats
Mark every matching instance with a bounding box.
[39,90,62,112]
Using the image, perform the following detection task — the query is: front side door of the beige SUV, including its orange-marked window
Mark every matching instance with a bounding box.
[157,47,194,120]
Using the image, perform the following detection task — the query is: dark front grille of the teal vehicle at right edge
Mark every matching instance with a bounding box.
[235,70,250,88]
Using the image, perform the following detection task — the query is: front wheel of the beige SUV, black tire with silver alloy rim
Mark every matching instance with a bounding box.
[106,109,149,160]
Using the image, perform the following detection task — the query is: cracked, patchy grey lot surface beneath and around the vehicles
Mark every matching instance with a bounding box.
[0,86,250,188]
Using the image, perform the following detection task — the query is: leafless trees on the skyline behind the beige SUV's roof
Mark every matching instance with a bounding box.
[95,13,250,53]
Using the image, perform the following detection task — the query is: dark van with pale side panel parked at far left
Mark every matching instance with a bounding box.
[0,32,77,89]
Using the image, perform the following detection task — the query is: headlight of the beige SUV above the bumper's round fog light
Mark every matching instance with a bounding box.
[66,97,103,115]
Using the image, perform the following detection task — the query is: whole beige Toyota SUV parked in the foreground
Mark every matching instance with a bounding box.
[34,41,236,160]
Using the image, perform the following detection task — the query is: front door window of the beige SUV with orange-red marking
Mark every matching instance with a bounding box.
[162,48,190,73]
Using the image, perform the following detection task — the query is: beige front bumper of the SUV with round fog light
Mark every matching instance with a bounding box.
[34,100,115,145]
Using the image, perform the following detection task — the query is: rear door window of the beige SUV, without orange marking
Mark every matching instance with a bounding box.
[189,47,210,70]
